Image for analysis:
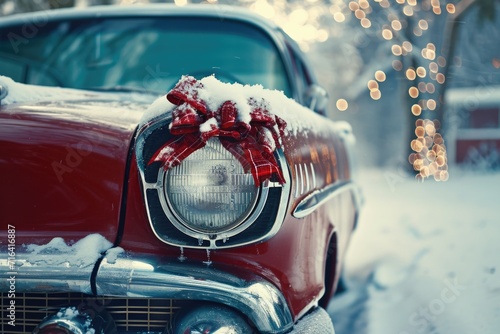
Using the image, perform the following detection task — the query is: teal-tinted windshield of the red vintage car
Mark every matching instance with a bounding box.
[0,17,291,96]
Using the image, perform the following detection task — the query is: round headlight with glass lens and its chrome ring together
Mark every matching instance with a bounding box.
[155,138,269,244]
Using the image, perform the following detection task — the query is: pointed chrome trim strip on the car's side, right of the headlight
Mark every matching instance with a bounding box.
[293,181,359,218]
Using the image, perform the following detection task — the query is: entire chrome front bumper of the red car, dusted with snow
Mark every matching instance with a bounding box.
[0,253,334,334]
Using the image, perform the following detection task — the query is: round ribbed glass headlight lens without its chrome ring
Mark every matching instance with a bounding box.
[163,138,259,234]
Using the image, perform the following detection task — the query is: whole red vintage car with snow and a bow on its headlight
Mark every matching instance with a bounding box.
[0,5,360,334]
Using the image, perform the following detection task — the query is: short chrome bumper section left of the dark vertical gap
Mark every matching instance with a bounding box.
[0,254,94,294]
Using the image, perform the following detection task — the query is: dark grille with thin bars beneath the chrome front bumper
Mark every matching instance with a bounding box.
[0,293,182,334]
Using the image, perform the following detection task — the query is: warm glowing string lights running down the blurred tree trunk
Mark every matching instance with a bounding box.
[356,0,455,181]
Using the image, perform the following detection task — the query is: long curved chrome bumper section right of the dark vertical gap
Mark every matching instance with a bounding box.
[96,255,293,334]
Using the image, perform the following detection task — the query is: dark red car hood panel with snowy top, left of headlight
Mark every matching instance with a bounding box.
[0,85,156,244]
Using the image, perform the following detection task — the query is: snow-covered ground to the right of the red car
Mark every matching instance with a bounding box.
[328,169,500,334]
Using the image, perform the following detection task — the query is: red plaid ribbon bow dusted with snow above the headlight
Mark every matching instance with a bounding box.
[149,76,286,187]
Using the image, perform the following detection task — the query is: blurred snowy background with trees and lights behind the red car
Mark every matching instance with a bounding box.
[0,0,500,334]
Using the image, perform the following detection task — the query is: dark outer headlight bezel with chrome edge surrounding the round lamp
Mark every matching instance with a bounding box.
[134,117,291,249]
